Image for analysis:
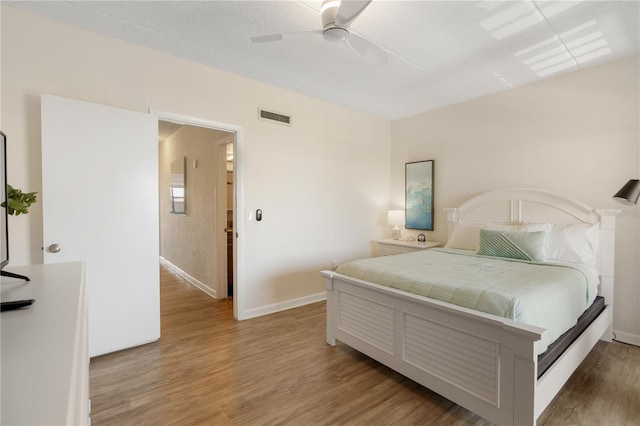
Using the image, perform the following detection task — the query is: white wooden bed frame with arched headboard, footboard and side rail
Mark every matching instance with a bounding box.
[322,189,619,425]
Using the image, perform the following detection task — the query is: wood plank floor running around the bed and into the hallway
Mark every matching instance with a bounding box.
[90,268,640,426]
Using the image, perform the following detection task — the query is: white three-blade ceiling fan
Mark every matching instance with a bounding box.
[251,0,389,65]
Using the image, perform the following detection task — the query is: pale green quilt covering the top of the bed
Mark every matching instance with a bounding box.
[336,249,598,354]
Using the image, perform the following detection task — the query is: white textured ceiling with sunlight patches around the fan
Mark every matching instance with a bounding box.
[3,0,640,119]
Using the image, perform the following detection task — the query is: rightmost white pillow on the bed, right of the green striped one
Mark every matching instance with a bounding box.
[546,223,600,266]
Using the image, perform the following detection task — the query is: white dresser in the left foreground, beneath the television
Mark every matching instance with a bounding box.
[0,262,90,425]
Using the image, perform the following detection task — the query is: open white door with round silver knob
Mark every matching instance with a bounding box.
[41,95,160,356]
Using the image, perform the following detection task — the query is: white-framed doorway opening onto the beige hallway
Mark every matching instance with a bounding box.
[155,112,240,318]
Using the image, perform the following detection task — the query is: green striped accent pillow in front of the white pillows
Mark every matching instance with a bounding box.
[476,229,547,261]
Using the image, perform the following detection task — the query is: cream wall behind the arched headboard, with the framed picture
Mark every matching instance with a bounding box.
[391,56,640,344]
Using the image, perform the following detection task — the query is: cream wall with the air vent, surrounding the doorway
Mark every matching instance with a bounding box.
[1,5,391,318]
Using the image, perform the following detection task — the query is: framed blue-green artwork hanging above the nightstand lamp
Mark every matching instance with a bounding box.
[405,160,434,231]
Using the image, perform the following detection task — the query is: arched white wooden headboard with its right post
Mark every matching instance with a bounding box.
[445,188,620,306]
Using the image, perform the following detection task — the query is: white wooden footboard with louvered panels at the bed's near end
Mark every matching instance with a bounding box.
[322,271,544,425]
